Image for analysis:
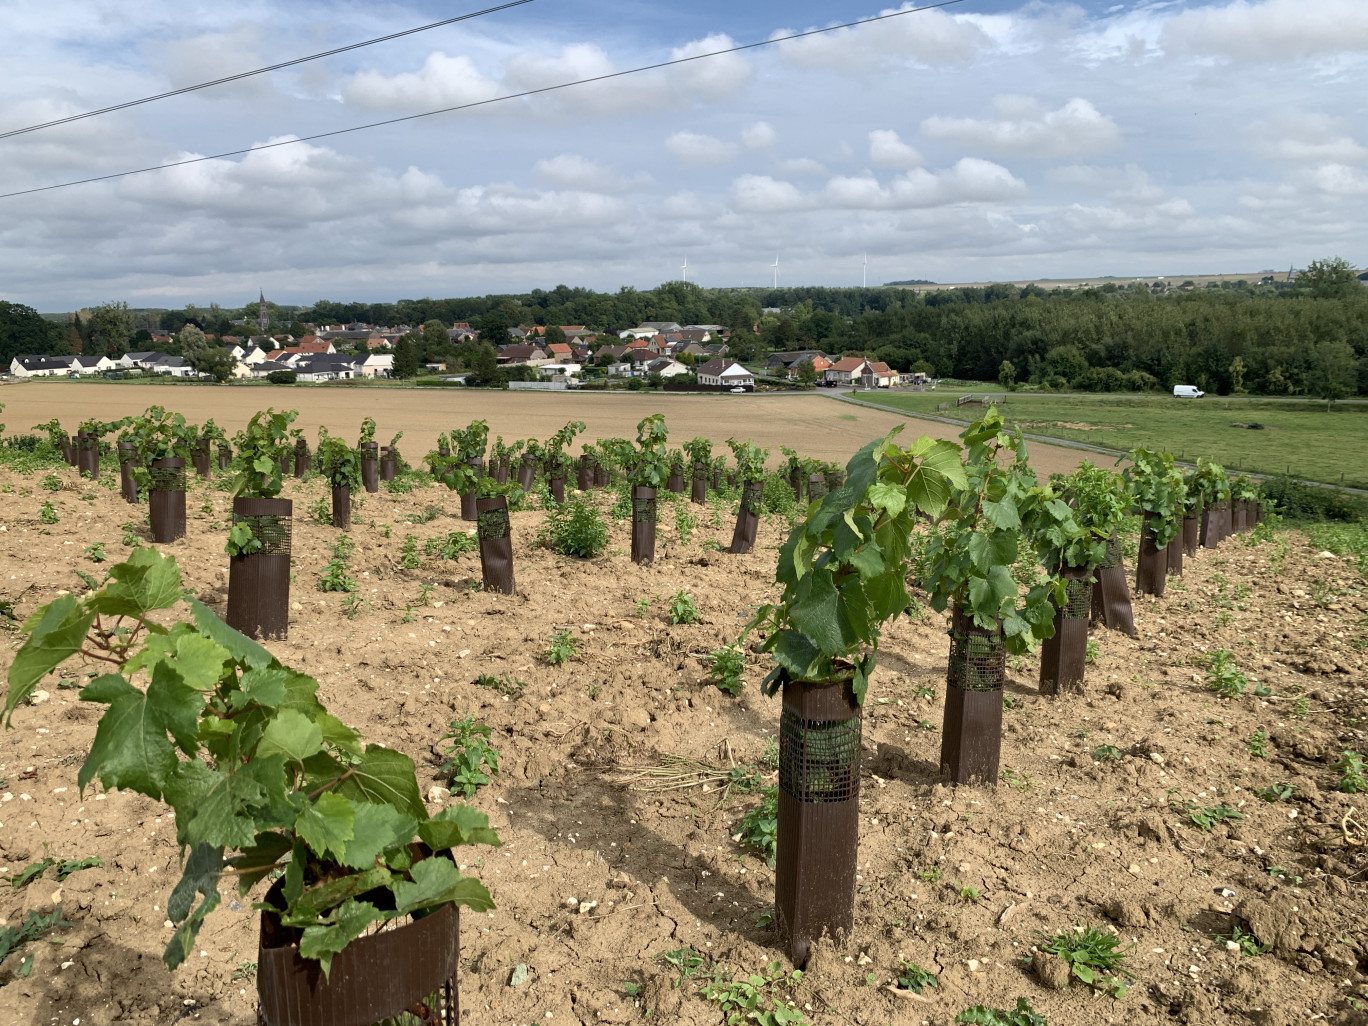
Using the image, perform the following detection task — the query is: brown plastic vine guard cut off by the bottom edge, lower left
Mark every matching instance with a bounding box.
[257,881,461,1026]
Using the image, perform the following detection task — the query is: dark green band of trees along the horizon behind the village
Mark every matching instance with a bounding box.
[0,257,1368,398]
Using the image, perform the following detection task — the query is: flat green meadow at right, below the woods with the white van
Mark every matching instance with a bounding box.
[859,391,1368,488]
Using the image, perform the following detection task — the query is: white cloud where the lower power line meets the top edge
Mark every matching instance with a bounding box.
[774,3,993,74]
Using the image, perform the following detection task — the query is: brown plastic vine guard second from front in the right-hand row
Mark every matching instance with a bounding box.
[940,607,1007,787]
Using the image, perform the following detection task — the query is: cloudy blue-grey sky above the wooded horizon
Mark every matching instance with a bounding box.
[0,0,1368,311]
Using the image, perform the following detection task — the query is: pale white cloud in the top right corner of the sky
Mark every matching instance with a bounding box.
[1160,0,1368,63]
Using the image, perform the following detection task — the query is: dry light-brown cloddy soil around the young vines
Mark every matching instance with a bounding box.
[0,465,1368,1026]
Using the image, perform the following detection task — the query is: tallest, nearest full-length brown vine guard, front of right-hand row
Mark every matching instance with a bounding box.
[774,680,863,967]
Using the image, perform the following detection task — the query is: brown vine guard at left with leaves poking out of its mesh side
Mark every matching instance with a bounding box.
[227,498,294,640]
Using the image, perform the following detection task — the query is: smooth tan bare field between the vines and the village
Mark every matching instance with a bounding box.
[0,382,1107,476]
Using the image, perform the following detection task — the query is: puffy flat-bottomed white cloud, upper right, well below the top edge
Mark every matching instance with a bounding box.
[922,96,1120,157]
